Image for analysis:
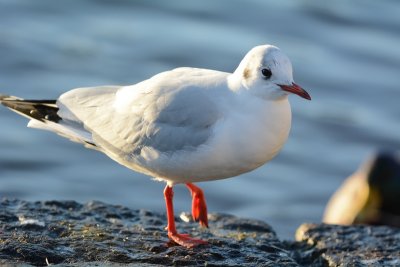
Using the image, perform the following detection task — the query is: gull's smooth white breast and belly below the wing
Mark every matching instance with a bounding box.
[148,93,291,183]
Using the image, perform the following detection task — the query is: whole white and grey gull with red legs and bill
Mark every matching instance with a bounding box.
[0,45,311,248]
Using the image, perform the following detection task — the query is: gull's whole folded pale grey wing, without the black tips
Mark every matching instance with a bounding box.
[57,82,218,158]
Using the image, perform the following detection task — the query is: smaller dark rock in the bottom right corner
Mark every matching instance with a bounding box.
[291,224,400,267]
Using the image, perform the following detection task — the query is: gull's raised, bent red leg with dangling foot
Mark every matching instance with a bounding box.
[186,183,208,227]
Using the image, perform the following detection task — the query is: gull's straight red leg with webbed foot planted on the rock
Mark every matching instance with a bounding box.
[164,185,207,248]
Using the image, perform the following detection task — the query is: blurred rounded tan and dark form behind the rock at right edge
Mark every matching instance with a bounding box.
[323,152,400,227]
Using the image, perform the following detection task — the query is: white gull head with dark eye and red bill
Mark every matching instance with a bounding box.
[230,45,311,100]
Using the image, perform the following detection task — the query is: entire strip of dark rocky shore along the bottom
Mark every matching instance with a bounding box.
[0,199,400,266]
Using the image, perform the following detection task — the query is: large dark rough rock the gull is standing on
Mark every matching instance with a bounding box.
[0,199,299,266]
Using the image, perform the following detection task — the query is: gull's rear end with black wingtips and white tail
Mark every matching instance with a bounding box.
[0,94,97,149]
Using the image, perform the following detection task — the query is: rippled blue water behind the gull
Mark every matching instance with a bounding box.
[0,0,400,238]
